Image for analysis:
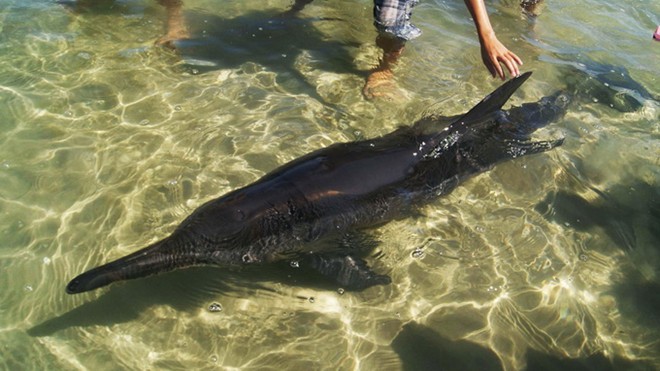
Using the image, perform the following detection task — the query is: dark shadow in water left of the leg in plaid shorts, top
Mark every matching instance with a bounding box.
[173,10,368,101]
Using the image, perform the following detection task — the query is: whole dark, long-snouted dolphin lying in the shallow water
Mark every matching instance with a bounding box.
[66,72,569,294]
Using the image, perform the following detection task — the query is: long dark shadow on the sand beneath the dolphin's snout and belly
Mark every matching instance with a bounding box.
[27,263,337,337]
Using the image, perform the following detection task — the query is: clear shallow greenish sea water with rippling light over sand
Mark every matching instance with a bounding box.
[0,0,660,370]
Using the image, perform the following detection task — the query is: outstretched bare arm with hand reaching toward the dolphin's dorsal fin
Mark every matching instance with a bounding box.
[465,0,522,80]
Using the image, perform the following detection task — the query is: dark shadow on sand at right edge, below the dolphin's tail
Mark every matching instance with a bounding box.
[536,179,660,354]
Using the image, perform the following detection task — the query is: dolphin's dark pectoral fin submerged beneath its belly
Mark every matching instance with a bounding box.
[307,254,392,290]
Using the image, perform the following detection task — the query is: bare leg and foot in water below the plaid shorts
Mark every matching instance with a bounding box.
[362,35,405,99]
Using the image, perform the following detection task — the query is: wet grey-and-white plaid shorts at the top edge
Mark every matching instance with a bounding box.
[374,0,422,41]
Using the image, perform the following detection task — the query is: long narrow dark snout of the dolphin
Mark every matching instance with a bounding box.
[66,237,195,294]
